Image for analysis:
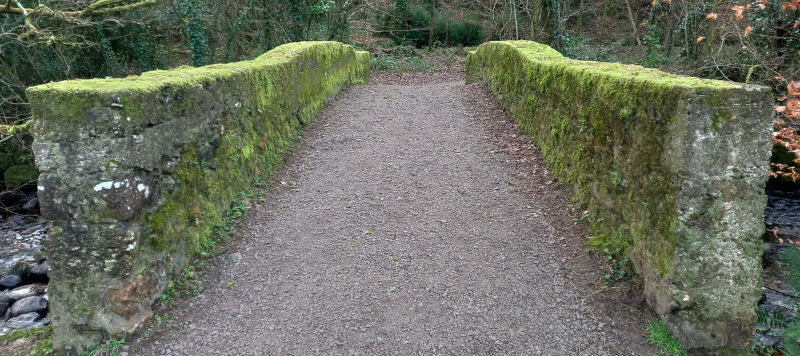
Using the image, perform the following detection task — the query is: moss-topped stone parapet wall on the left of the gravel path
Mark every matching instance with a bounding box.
[27,42,369,353]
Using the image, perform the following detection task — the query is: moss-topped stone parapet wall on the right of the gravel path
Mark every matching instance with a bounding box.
[467,41,772,354]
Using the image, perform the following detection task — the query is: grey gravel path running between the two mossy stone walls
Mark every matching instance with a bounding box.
[136,82,651,355]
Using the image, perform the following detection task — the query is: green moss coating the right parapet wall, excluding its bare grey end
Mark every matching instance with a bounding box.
[467,41,704,273]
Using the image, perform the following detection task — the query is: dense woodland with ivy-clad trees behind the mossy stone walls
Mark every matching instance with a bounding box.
[0,0,800,192]
